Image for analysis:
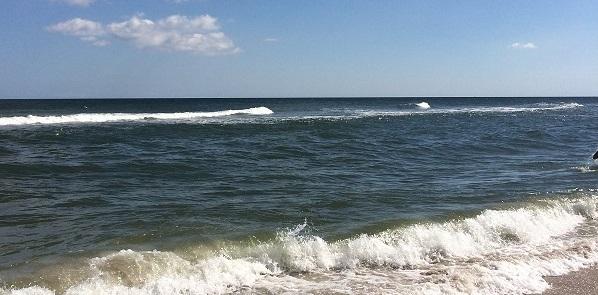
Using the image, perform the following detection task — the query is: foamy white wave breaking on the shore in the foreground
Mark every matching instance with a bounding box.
[0,195,598,295]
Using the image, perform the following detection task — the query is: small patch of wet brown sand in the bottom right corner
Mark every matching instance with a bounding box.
[542,266,598,295]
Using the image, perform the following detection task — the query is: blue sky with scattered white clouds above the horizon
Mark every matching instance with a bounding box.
[0,0,598,98]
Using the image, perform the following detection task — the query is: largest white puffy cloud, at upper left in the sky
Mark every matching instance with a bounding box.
[48,15,240,55]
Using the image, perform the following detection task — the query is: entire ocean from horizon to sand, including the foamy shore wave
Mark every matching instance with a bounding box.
[0,97,598,295]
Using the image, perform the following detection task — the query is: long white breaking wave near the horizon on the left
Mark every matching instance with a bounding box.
[0,107,273,126]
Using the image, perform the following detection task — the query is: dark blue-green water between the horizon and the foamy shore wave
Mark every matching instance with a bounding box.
[0,98,598,294]
